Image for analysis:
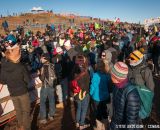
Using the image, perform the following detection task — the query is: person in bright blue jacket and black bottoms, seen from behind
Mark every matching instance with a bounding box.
[90,59,110,130]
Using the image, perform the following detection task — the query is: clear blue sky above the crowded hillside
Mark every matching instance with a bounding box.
[0,0,160,23]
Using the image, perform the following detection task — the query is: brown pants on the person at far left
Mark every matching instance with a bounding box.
[11,93,31,130]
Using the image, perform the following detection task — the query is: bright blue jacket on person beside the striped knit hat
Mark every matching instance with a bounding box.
[90,72,110,101]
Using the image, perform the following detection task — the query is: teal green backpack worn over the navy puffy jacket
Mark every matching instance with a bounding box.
[127,85,154,119]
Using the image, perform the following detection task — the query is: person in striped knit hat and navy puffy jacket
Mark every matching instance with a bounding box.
[110,62,141,130]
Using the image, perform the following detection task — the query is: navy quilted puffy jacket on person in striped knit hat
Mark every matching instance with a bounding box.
[110,83,140,130]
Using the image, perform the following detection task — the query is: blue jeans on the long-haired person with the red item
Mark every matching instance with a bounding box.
[76,94,90,125]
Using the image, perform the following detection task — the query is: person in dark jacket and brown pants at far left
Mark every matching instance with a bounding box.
[0,44,31,130]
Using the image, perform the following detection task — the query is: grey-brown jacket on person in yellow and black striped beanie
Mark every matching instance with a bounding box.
[128,63,155,92]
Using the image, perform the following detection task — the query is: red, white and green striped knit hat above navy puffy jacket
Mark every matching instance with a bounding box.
[111,62,128,83]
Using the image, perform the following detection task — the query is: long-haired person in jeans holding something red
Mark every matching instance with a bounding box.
[71,55,90,130]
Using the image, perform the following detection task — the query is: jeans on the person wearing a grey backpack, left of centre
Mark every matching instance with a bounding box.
[40,87,56,119]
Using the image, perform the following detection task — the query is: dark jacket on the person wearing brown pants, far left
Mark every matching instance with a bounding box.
[0,58,30,96]
